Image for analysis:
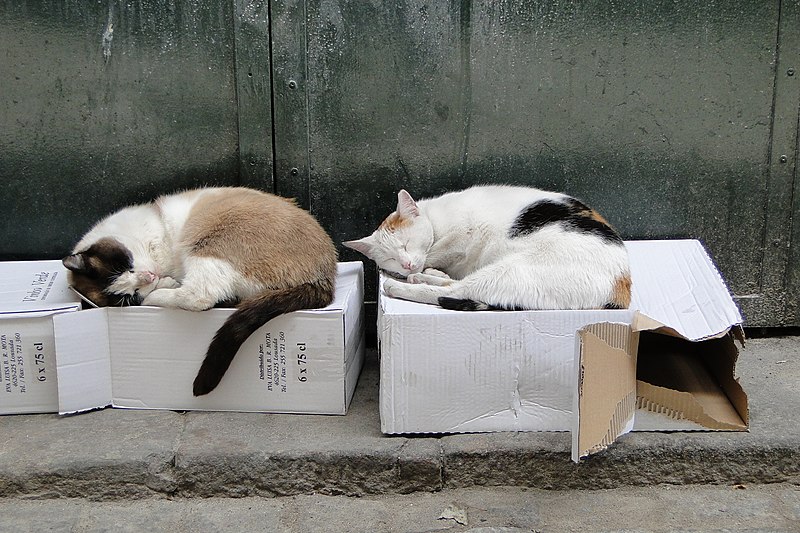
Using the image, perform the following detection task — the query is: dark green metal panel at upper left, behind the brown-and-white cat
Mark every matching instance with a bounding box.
[0,0,238,259]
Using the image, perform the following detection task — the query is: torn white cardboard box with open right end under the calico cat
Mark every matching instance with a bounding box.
[378,240,748,461]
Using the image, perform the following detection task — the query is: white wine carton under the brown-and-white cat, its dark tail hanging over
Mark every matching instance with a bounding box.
[54,262,364,414]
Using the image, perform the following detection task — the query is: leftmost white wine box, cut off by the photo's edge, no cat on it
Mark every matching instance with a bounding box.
[0,261,81,414]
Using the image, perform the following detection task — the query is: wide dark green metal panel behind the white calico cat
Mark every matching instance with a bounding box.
[308,0,797,324]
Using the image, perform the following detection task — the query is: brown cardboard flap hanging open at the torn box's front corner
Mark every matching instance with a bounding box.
[572,323,639,461]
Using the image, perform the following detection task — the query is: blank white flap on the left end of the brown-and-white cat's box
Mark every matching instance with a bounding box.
[53,309,113,415]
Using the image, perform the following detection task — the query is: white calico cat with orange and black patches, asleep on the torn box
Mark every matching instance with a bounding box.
[343,185,631,311]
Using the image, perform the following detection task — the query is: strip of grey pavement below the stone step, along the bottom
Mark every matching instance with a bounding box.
[0,484,800,533]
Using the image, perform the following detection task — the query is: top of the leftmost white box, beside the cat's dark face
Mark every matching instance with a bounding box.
[0,260,80,319]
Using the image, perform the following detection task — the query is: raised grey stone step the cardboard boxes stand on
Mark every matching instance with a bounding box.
[0,337,800,498]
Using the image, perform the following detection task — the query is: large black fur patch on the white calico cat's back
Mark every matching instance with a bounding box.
[509,198,622,245]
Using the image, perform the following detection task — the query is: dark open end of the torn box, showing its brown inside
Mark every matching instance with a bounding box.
[637,333,748,431]
